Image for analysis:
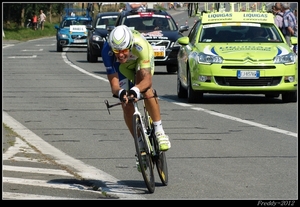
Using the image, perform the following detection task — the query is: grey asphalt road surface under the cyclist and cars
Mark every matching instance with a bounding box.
[3,4,298,201]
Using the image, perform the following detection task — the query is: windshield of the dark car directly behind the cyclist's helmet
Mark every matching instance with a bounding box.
[121,15,177,31]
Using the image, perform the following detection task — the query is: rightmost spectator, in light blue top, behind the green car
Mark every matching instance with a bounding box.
[281,3,298,48]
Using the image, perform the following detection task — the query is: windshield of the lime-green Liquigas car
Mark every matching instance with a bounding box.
[199,23,283,43]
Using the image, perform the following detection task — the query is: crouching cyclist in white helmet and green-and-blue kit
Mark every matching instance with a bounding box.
[102,25,171,167]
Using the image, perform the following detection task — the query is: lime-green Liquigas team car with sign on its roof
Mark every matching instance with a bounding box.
[177,2,298,103]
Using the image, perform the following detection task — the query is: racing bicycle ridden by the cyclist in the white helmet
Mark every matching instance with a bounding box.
[104,90,169,193]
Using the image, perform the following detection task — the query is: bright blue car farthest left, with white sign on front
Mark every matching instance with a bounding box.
[55,9,92,52]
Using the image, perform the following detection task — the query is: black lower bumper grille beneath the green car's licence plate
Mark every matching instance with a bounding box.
[214,76,282,86]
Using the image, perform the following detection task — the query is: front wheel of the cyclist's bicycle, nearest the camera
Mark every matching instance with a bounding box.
[133,115,155,193]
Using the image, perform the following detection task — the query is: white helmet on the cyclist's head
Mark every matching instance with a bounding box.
[108,25,133,50]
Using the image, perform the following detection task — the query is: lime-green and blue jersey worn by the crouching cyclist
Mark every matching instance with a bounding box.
[102,30,154,90]
